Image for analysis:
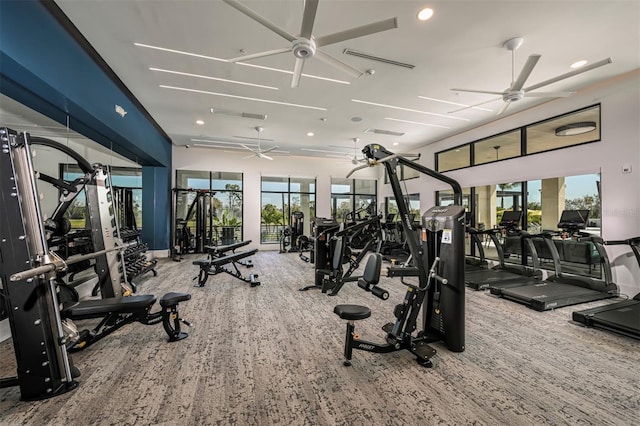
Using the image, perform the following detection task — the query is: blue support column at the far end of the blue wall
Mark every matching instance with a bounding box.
[142,166,171,256]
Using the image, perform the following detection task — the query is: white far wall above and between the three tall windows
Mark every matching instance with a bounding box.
[172,147,379,250]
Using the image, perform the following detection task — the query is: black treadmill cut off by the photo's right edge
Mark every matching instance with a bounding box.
[573,237,640,340]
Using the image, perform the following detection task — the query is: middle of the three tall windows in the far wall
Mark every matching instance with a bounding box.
[260,176,316,244]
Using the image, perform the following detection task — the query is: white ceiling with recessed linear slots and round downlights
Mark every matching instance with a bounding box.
[56,0,640,161]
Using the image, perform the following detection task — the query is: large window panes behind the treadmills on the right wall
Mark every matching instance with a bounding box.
[437,173,601,277]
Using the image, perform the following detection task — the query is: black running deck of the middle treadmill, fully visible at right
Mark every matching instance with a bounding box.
[500,281,617,311]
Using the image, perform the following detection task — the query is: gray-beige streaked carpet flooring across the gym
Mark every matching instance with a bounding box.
[0,252,640,426]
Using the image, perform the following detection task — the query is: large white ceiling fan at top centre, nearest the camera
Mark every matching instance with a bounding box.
[223,0,398,88]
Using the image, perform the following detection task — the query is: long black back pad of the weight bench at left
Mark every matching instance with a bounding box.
[65,294,156,319]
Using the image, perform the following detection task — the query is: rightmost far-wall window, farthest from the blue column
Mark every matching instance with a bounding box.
[331,178,377,222]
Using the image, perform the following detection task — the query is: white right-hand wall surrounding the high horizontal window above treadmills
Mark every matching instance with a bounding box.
[396,69,640,296]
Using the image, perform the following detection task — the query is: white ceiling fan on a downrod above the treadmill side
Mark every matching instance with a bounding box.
[449,37,612,115]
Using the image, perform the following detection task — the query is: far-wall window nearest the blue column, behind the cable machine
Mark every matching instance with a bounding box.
[174,170,243,243]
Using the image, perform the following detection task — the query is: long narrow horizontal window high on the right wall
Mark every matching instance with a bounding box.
[435,105,601,172]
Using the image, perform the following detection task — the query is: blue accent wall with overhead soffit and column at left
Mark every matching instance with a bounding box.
[0,0,172,249]
